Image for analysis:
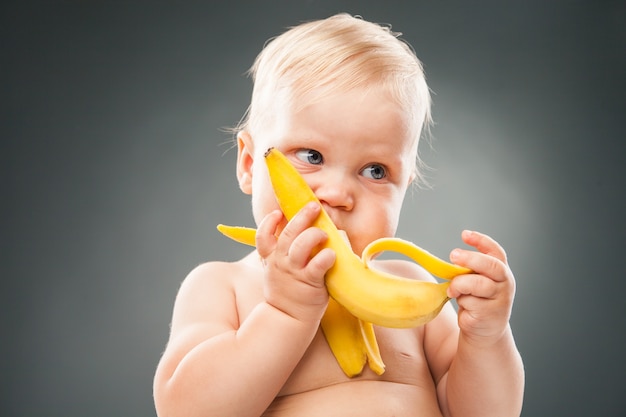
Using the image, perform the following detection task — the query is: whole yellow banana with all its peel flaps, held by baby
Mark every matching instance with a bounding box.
[218,148,472,377]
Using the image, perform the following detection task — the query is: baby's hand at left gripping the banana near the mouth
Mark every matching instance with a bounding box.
[256,203,335,322]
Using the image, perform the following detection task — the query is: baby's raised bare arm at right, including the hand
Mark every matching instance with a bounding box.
[427,231,524,417]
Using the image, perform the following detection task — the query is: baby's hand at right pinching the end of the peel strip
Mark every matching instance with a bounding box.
[448,230,515,344]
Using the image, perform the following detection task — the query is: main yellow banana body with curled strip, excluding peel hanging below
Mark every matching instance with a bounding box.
[265,148,471,328]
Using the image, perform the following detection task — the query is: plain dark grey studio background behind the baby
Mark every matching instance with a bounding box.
[0,1,626,416]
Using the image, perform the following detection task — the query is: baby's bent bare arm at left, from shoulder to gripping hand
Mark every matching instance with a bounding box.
[154,204,334,417]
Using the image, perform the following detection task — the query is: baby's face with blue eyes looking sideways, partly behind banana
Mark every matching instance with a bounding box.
[243,90,416,253]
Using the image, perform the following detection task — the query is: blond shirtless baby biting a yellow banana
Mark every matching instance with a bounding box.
[154,14,524,417]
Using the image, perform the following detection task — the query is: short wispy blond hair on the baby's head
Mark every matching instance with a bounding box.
[238,13,432,177]
